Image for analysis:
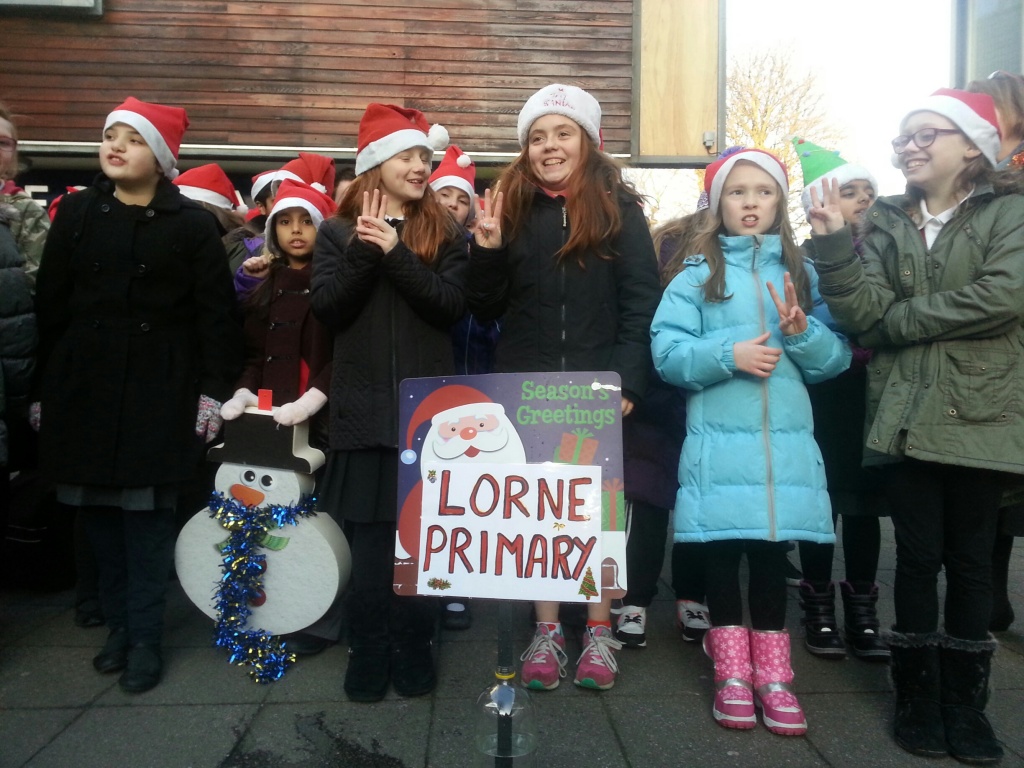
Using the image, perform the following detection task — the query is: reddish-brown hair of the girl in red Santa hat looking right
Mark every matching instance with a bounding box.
[335,166,462,264]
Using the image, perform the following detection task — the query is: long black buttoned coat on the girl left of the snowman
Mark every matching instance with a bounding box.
[36,175,243,487]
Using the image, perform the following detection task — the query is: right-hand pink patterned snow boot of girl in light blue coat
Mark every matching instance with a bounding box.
[751,630,807,736]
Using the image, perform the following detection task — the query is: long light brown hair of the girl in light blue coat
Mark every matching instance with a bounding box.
[690,191,813,312]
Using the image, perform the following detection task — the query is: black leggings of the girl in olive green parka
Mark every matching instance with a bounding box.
[886,460,1002,640]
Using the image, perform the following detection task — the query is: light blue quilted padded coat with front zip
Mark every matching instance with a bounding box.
[651,234,851,543]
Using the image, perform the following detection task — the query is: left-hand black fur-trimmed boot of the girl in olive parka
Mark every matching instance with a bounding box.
[886,632,948,758]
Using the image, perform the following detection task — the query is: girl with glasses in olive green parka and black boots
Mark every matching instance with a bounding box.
[810,88,1024,762]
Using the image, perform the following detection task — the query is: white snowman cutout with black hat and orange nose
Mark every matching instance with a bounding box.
[174,399,351,635]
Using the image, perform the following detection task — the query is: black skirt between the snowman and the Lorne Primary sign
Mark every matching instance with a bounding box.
[316,447,398,524]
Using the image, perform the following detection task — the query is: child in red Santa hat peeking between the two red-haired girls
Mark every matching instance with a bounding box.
[430,144,487,630]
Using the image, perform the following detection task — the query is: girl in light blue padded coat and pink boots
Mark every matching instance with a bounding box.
[651,150,850,735]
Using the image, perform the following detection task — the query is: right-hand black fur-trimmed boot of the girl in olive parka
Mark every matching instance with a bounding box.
[939,637,1002,764]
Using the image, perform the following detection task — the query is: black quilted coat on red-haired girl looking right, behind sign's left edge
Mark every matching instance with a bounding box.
[310,218,467,451]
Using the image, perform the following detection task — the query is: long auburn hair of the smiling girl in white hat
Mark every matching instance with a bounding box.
[496,129,640,266]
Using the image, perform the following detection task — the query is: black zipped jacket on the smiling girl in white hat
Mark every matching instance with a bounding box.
[466,189,662,401]
